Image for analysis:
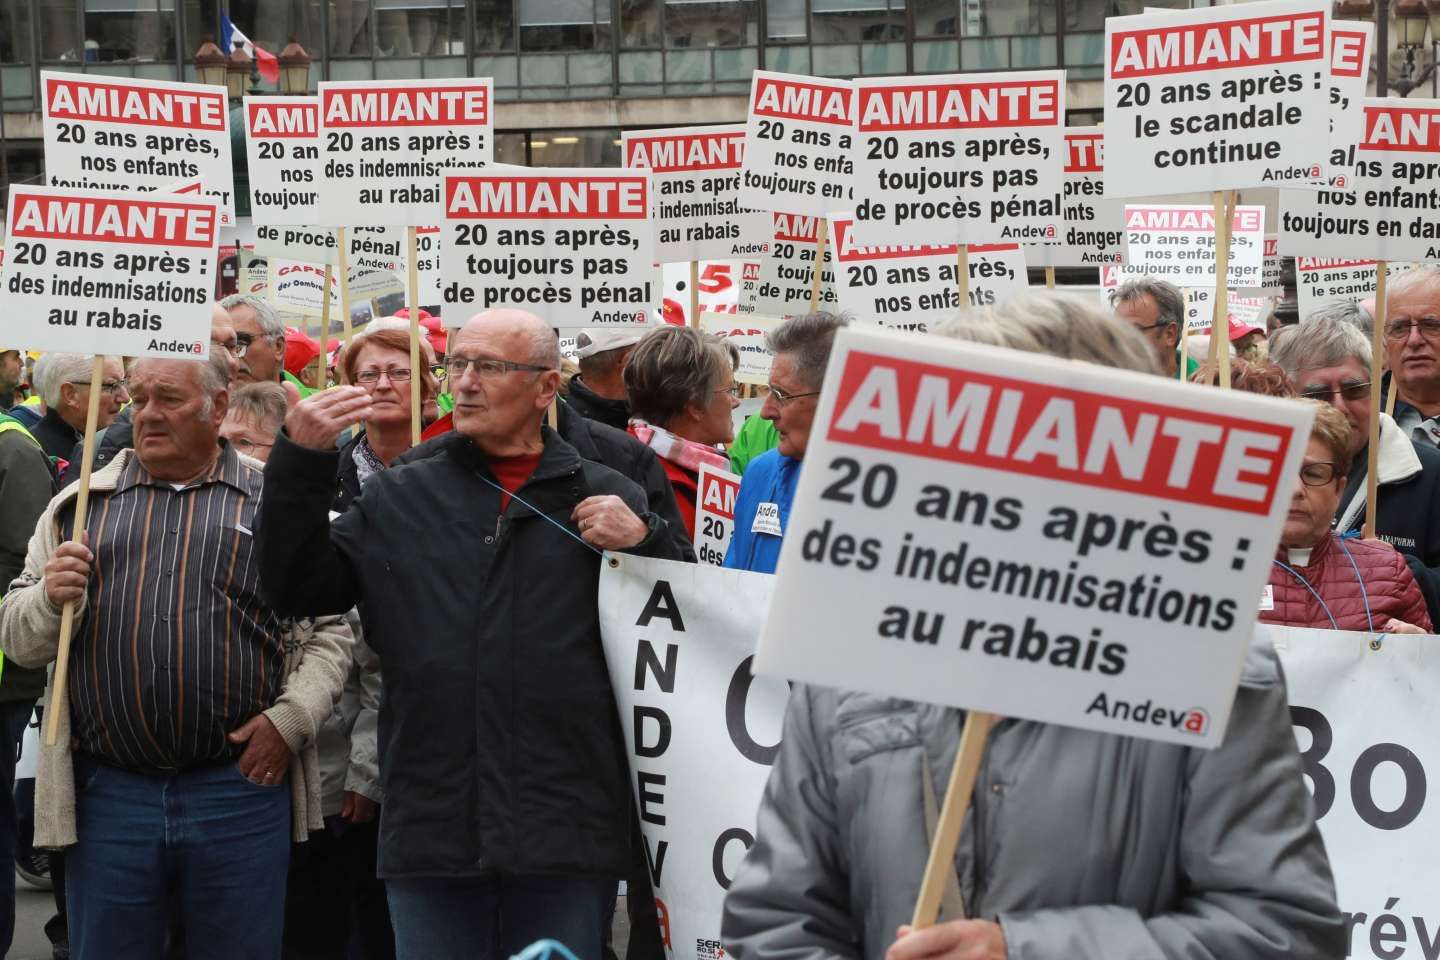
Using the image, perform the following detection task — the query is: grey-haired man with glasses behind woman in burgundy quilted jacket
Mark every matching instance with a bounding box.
[1270,311,1440,617]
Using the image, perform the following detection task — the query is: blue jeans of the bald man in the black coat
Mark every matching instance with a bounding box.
[384,875,616,960]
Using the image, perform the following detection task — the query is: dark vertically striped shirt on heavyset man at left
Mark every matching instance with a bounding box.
[66,446,285,773]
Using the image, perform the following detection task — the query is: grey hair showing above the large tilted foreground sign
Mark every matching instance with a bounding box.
[935,292,1161,374]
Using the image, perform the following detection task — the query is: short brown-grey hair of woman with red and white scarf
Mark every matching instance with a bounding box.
[625,325,740,426]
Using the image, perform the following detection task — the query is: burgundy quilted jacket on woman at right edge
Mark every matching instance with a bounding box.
[1260,534,1431,633]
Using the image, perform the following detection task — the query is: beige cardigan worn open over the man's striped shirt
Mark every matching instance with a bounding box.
[0,450,354,849]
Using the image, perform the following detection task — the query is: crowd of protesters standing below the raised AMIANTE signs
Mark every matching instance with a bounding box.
[0,266,1440,960]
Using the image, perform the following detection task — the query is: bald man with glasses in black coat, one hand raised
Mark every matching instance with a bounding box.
[256,311,678,960]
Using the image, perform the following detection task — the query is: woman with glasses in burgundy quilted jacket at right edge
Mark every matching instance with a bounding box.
[1260,402,1430,633]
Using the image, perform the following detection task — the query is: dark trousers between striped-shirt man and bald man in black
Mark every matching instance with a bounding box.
[284,816,395,960]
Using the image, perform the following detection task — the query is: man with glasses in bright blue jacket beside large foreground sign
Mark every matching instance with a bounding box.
[724,312,850,573]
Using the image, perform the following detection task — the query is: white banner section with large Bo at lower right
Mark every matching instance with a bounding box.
[1267,628,1440,960]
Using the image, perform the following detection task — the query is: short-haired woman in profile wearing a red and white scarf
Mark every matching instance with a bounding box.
[625,327,740,538]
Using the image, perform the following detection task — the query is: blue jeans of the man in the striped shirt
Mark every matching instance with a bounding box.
[65,757,289,960]
